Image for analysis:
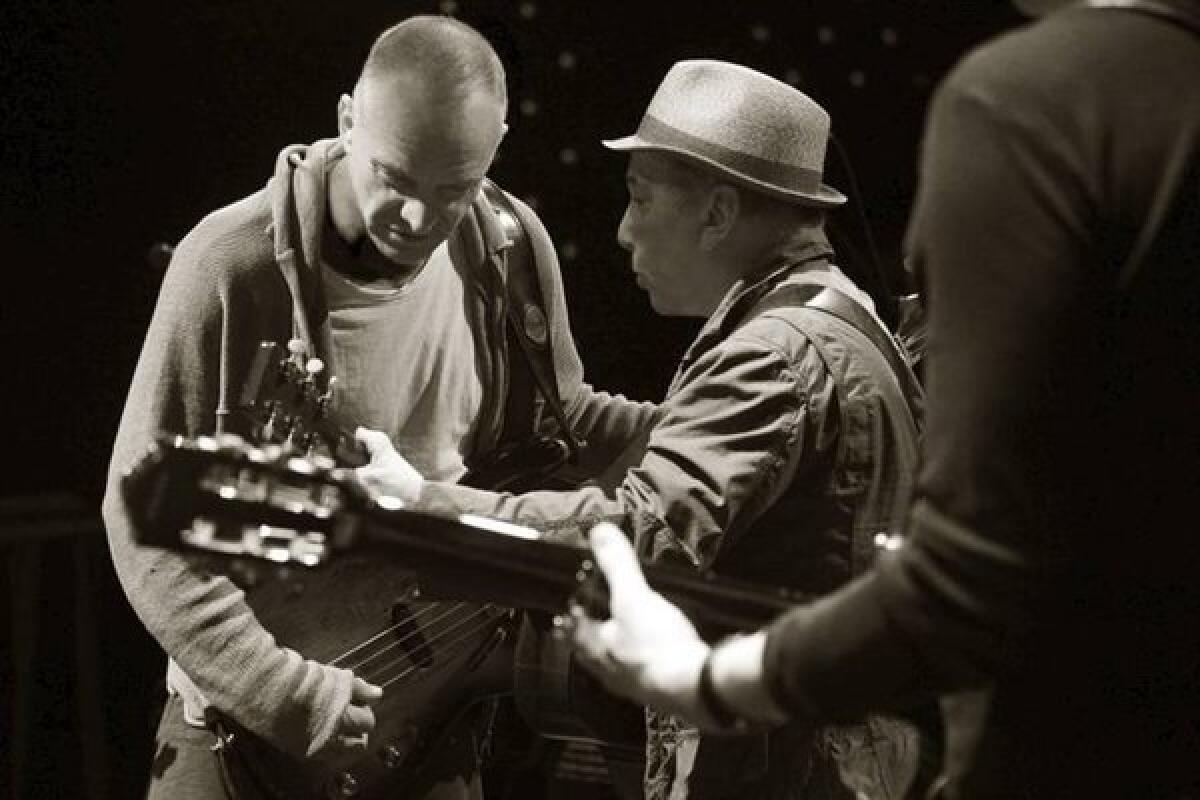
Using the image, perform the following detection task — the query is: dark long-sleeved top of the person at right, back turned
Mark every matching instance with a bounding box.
[766,0,1200,798]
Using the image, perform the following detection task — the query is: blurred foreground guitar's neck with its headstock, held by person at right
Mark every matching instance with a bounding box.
[122,434,809,637]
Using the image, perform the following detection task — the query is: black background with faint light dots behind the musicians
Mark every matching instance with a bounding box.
[0,0,1020,798]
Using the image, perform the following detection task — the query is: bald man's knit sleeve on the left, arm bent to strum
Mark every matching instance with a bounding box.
[103,217,353,754]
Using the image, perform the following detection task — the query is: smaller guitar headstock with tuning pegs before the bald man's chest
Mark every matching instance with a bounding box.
[236,339,367,467]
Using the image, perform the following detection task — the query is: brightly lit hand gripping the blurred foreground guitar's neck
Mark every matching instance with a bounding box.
[571,523,708,722]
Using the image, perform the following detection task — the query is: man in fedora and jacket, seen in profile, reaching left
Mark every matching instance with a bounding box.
[360,60,919,800]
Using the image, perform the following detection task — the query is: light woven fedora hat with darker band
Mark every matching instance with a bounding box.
[604,60,846,207]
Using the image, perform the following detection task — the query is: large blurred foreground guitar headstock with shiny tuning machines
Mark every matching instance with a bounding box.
[121,434,372,567]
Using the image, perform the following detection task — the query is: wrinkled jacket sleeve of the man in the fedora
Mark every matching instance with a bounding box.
[418,323,832,566]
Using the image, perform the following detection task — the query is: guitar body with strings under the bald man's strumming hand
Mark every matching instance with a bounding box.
[217,554,515,800]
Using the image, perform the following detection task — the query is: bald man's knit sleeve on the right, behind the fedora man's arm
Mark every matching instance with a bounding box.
[510,196,658,477]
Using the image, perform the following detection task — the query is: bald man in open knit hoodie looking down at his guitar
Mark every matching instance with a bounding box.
[104,17,654,800]
